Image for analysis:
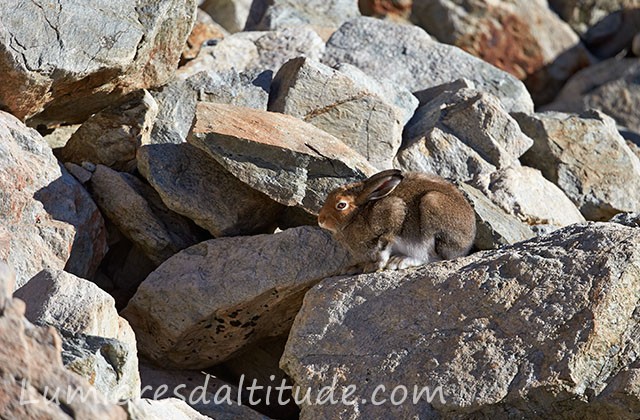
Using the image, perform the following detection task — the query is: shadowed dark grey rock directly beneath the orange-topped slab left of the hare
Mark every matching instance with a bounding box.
[138,143,283,237]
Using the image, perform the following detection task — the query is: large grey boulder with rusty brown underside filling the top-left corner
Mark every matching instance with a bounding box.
[0,0,197,123]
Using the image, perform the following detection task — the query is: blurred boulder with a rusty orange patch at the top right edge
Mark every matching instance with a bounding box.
[411,0,590,103]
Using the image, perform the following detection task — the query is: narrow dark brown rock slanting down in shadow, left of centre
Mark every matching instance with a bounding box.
[90,165,199,264]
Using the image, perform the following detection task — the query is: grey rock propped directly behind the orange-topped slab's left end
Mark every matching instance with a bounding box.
[150,69,271,144]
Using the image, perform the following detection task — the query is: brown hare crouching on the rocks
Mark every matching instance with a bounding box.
[319,170,475,271]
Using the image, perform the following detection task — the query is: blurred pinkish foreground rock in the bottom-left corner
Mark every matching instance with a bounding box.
[0,261,127,420]
